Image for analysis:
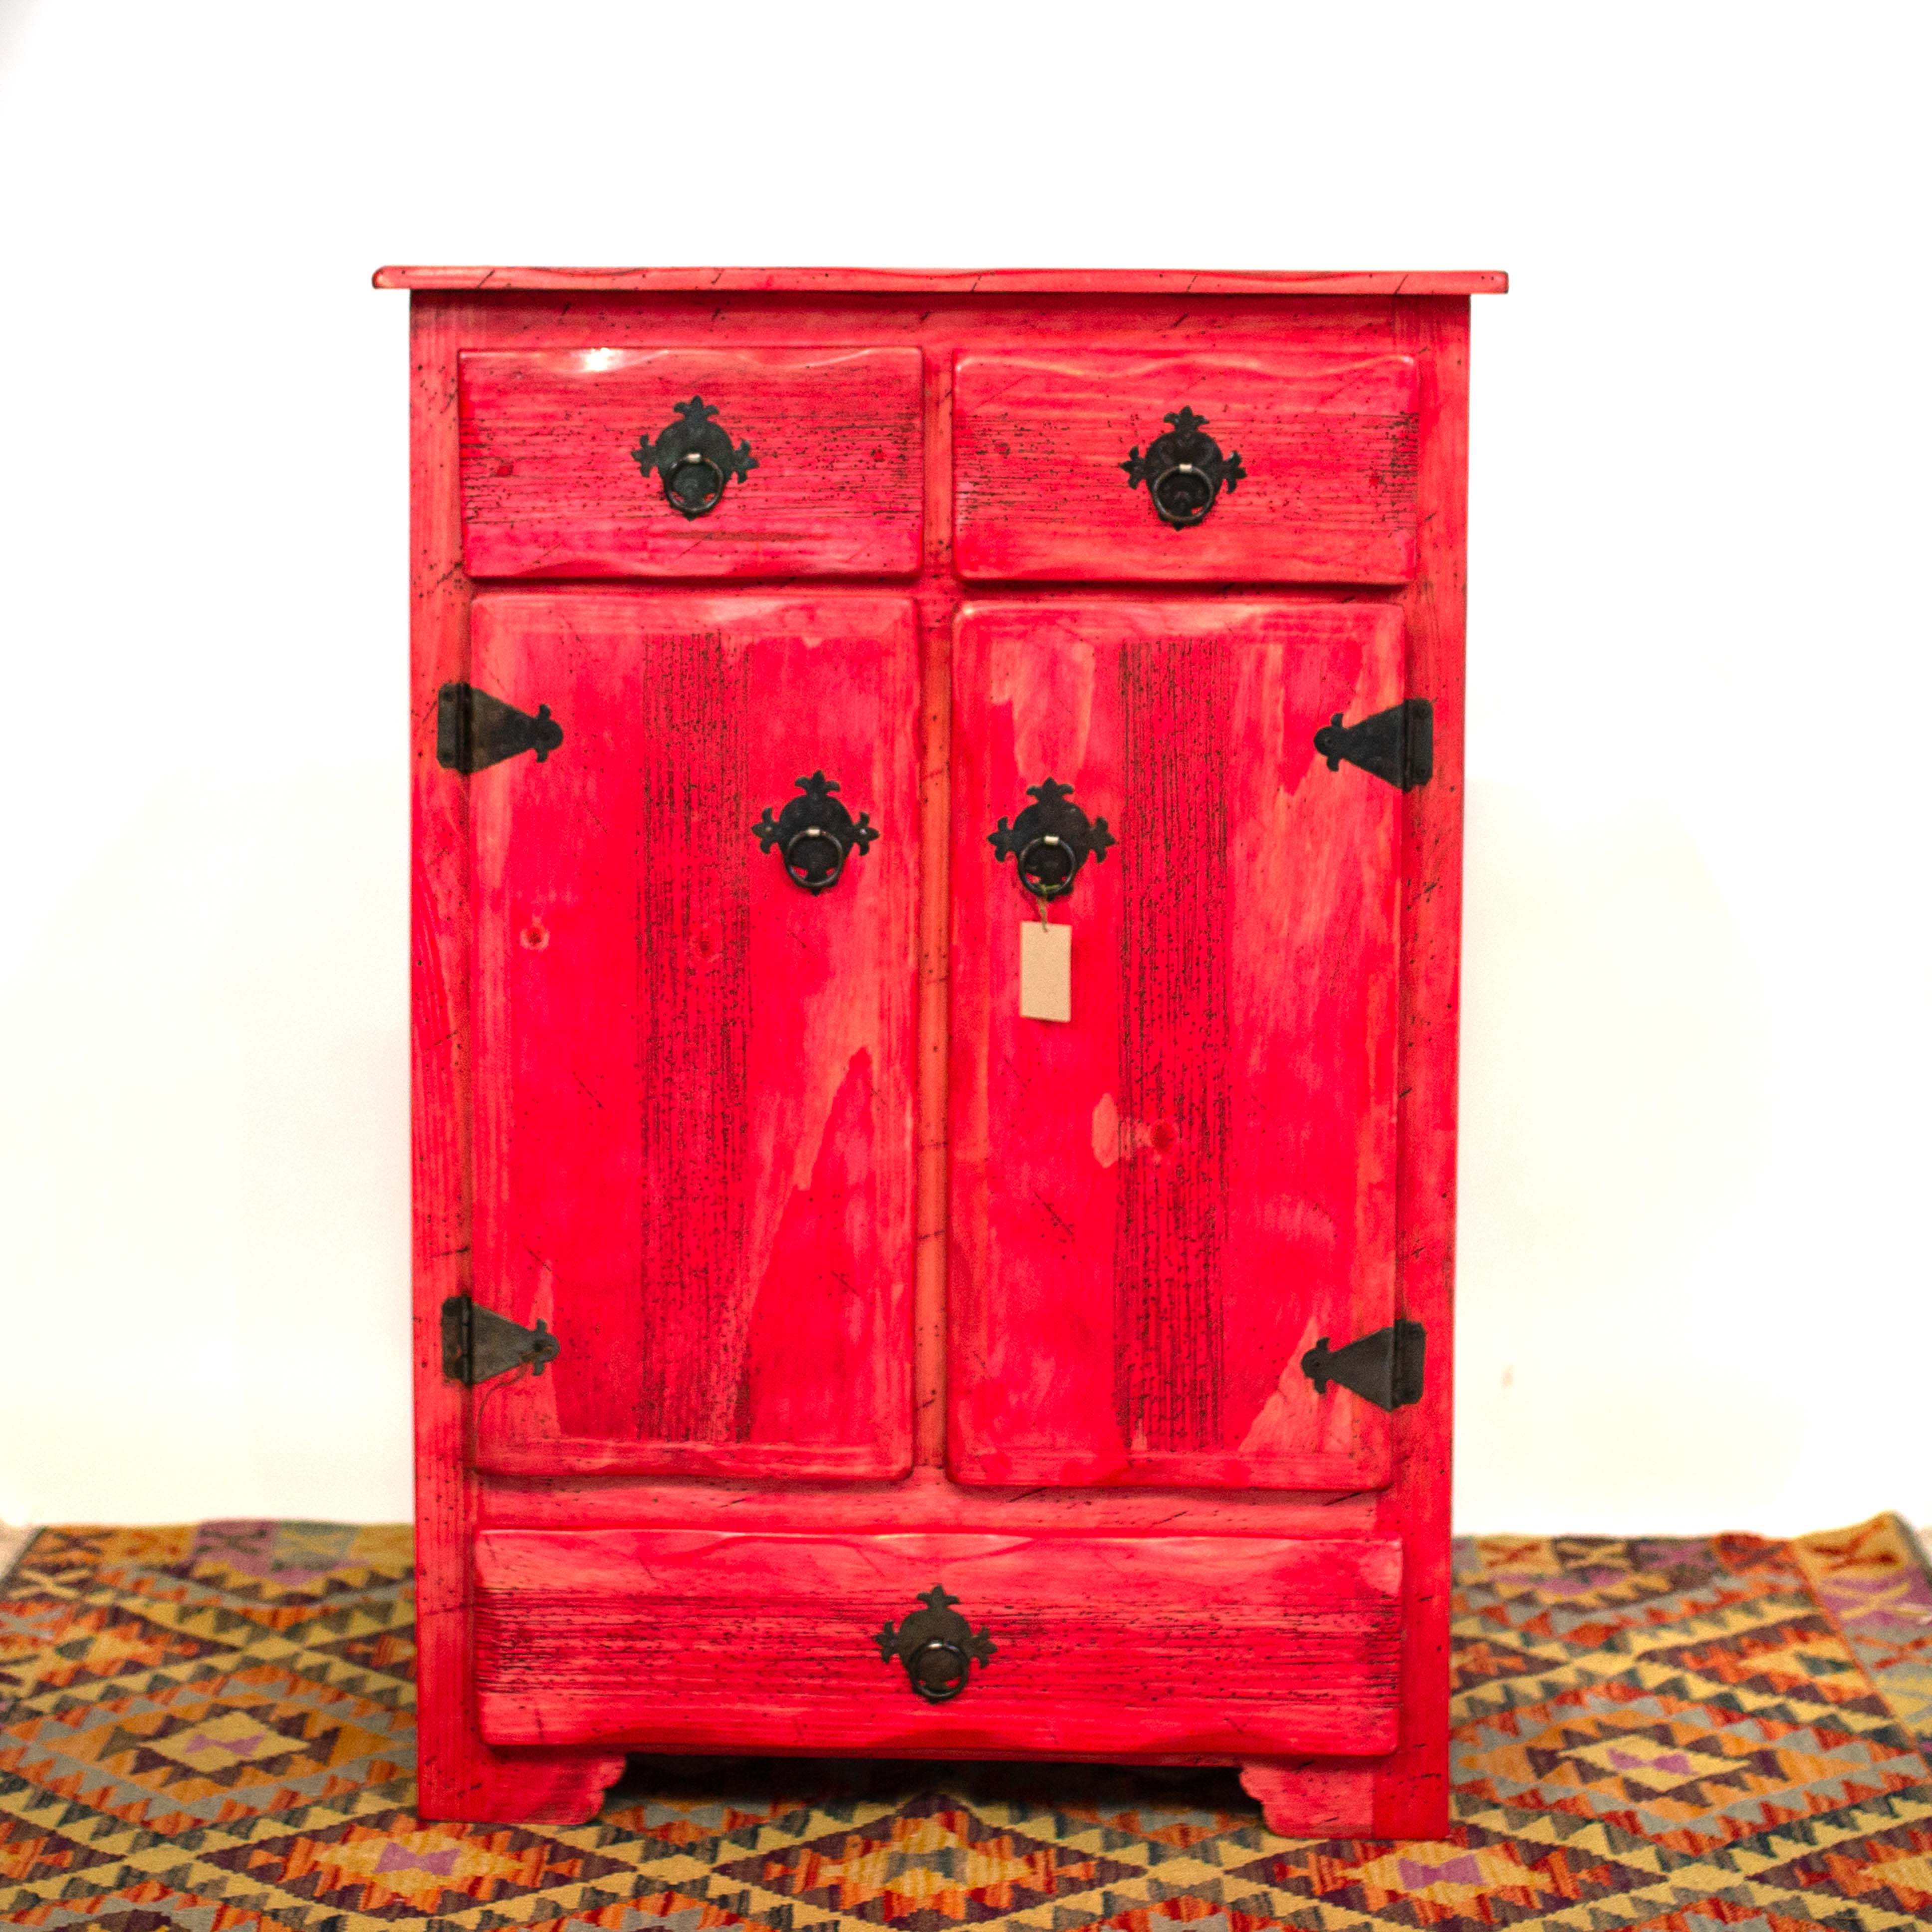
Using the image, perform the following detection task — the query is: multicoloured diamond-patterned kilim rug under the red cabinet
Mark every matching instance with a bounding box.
[0,1517,1932,1932]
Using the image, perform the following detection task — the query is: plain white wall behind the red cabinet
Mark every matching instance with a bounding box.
[0,0,1932,1530]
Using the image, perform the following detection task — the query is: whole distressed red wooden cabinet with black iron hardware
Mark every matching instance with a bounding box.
[379,270,1501,1835]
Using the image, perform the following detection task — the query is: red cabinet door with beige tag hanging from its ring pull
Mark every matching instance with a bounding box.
[949,601,1403,1489]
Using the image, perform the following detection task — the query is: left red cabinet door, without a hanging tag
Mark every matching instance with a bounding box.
[464,591,918,1476]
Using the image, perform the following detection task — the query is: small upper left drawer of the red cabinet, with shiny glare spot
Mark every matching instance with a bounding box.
[460,348,924,578]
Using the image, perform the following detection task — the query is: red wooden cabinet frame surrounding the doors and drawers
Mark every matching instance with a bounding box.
[379,270,1476,1837]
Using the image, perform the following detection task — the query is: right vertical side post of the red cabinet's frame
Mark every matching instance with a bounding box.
[1376,297,1468,1837]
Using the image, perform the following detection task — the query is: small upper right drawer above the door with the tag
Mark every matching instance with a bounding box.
[953,350,1416,583]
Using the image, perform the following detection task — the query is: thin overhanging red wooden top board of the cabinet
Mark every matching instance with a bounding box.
[373,266,1509,297]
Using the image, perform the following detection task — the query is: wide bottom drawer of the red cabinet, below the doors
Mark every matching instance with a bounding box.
[476,1528,1403,1758]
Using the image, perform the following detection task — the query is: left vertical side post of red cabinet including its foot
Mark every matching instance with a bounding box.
[410,289,624,1824]
